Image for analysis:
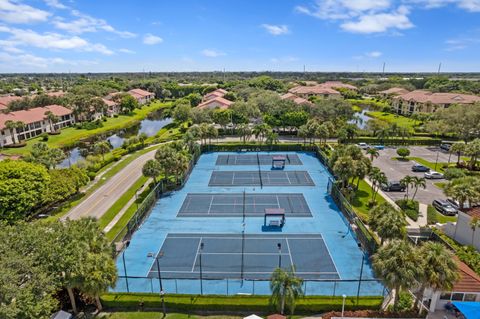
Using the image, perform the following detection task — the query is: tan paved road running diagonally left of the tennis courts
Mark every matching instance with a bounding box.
[62,148,156,220]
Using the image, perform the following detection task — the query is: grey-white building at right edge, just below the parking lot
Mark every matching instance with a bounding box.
[442,206,480,251]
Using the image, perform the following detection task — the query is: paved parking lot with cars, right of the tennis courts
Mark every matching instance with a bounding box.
[373,146,450,204]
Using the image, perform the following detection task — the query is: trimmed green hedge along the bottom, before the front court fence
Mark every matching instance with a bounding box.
[101,293,383,314]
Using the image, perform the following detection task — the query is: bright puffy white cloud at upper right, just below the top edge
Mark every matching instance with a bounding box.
[340,6,414,33]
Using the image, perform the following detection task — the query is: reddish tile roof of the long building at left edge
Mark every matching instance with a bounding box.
[0,105,72,130]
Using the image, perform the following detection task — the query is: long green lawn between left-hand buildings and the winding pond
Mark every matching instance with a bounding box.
[1,102,171,155]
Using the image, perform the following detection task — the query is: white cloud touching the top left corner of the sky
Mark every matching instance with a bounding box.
[0,0,51,24]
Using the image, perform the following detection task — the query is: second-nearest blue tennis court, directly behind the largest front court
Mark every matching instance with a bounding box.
[177,193,312,217]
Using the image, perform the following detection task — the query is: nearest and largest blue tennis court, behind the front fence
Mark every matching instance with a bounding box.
[149,233,340,279]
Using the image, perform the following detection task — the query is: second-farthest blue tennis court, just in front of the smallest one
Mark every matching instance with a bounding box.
[208,171,315,186]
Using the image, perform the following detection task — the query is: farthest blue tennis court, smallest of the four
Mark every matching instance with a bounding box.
[215,154,303,166]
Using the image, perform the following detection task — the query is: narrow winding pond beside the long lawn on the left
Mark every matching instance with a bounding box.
[58,112,172,168]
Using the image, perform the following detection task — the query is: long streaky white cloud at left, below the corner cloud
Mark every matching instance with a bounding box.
[0,26,113,55]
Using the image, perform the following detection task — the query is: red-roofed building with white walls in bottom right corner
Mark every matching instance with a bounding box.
[424,260,480,312]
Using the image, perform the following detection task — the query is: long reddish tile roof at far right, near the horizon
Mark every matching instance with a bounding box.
[396,90,480,104]
